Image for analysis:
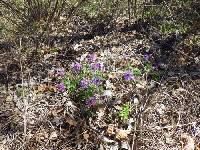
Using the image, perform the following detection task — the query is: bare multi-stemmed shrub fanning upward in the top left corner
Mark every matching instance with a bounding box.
[0,0,70,35]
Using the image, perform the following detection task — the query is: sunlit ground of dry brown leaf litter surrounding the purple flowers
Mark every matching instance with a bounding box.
[0,15,200,150]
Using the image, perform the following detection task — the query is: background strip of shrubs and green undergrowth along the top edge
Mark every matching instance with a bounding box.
[0,0,199,39]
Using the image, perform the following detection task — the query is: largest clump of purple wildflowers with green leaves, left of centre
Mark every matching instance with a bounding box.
[56,54,105,106]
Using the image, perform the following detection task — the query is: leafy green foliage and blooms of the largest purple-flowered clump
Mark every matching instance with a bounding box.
[56,55,105,105]
